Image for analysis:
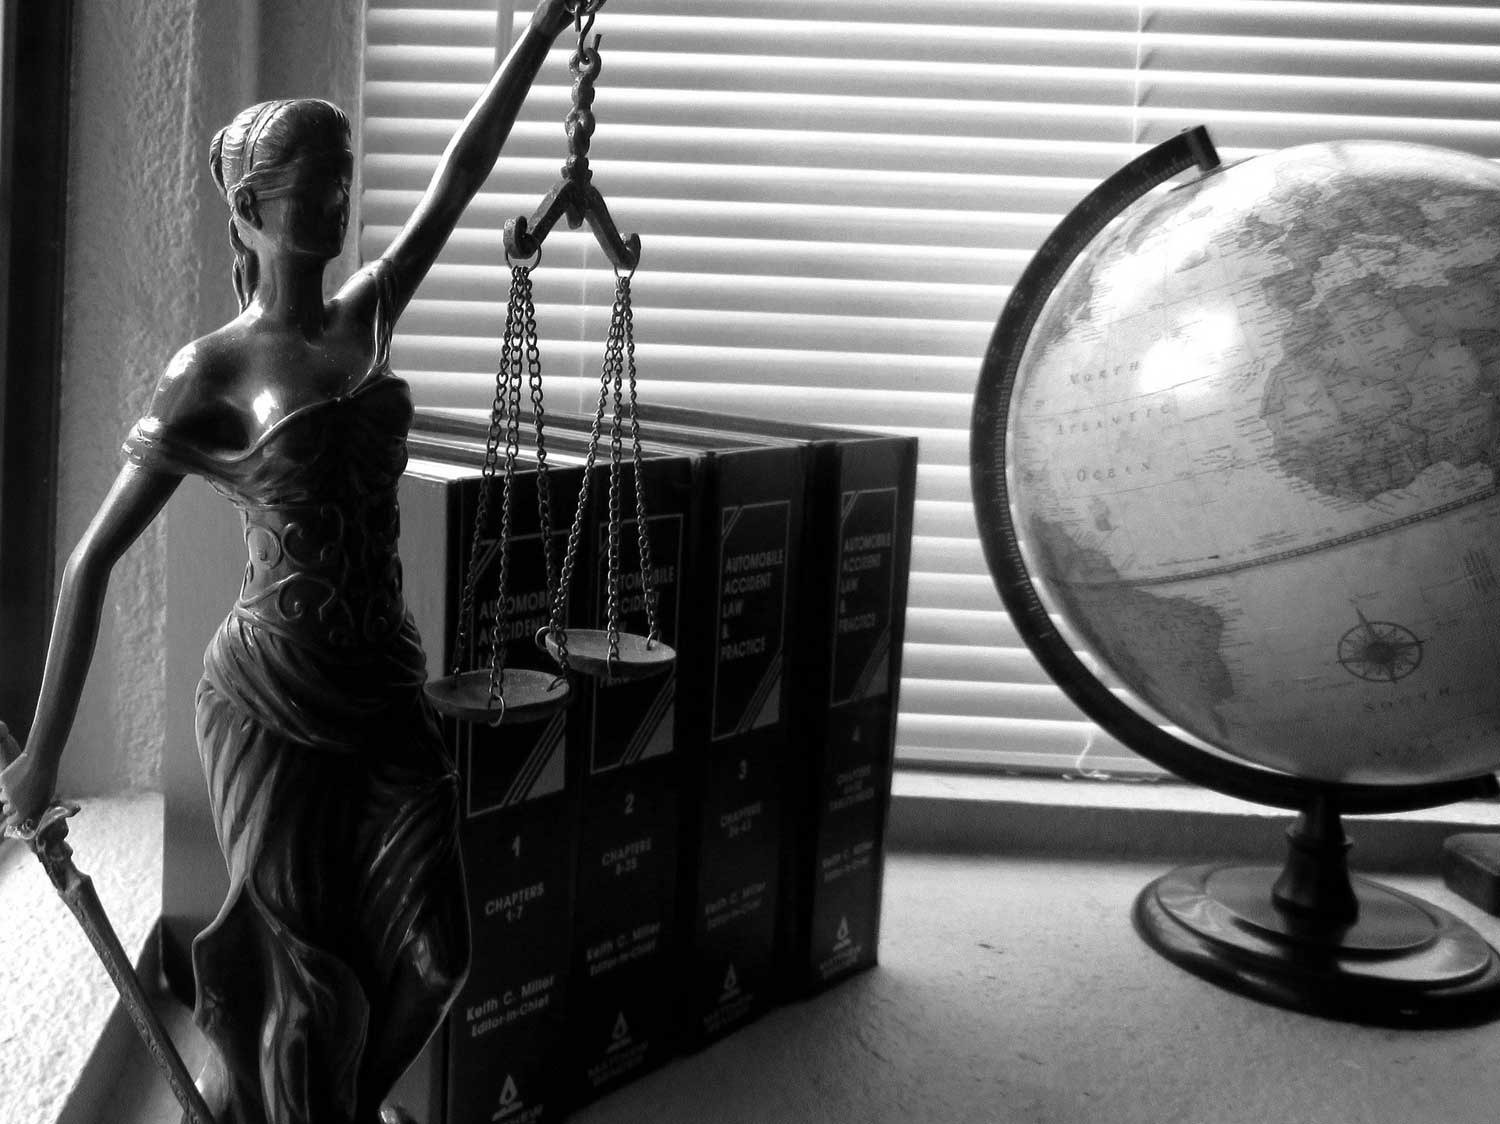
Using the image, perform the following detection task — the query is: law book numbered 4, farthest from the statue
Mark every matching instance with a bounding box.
[641,404,917,995]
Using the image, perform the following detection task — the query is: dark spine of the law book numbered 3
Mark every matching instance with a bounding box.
[680,447,803,1047]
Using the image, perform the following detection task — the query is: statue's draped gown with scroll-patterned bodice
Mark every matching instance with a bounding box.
[126,291,467,1124]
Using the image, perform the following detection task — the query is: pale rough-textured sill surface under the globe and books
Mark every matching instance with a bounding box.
[14,770,1500,1124]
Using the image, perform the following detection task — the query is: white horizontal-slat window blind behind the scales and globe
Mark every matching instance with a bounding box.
[360,0,1500,773]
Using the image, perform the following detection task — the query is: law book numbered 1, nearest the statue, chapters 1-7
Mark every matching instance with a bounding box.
[396,450,590,1124]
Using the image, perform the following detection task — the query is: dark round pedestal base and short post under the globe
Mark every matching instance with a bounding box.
[1134,797,1500,1026]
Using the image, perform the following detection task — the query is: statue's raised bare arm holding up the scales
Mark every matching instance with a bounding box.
[347,0,582,318]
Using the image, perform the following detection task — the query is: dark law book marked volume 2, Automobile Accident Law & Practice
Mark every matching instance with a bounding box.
[414,411,693,1106]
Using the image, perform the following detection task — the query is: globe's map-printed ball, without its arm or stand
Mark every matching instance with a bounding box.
[1007,141,1500,783]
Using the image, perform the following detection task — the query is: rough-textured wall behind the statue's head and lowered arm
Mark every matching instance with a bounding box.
[59,0,363,792]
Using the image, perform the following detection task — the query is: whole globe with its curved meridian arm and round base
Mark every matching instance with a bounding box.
[971,128,1500,1026]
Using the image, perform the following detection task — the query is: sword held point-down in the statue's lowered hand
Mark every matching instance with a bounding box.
[0,728,215,1124]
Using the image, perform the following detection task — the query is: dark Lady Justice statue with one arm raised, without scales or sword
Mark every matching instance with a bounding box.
[0,0,602,1124]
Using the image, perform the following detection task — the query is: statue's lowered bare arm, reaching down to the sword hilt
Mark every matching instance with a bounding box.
[0,464,182,827]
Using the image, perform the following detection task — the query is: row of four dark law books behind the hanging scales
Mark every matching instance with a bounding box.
[398,407,917,1124]
